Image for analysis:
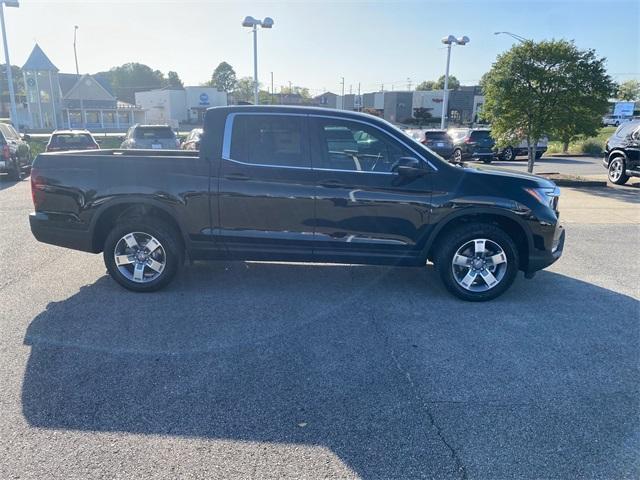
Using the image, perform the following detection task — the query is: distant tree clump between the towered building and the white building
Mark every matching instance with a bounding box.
[96,63,166,103]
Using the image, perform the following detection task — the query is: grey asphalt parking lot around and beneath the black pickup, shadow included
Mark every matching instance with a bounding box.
[0,174,640,479]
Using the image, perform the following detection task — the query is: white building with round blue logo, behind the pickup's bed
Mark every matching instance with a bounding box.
[136,87,227,127]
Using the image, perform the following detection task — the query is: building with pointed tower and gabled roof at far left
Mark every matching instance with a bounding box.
[18,44,145,131]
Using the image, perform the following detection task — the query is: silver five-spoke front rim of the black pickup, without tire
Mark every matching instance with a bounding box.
[451,238,507,292]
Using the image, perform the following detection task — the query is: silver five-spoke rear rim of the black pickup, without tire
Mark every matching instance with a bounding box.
[113,232,167,283]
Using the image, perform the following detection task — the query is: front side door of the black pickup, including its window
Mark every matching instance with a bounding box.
[309,116,433,263]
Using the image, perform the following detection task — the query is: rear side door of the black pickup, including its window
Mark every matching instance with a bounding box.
[218,112,316,260]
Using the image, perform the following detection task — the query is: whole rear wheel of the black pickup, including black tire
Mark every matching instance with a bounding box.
[103,218,184,292]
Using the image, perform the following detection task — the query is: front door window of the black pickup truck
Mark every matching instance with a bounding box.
[311,118,416,173]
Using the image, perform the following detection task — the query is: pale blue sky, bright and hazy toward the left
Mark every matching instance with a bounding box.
[5,0,640,95]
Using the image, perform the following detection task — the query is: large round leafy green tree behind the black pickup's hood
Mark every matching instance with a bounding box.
[482,40,614,173]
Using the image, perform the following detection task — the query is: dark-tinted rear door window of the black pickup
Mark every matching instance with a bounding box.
[229,115,311,167]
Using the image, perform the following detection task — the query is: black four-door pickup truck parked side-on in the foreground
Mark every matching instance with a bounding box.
[30,106,564,301]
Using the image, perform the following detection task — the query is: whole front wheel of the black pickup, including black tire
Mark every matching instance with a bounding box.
[434,222,520,302]
